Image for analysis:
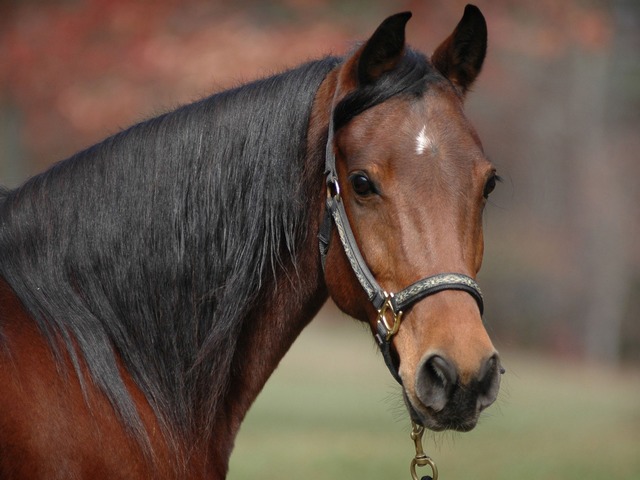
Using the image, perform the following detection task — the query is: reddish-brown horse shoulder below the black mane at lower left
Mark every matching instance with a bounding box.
[0,279,175,479]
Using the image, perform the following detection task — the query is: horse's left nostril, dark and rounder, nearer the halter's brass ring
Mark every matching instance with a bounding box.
[416,355,458,412]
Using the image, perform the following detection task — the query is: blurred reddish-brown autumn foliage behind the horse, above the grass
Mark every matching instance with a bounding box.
[0,0,640,360]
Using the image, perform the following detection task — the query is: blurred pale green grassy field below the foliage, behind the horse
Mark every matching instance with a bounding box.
[228,310,640,480]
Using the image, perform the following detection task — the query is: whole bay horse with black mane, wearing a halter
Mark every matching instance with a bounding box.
[0,5,502,479]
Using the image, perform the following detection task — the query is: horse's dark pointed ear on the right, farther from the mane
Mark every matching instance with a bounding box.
[431,5,487,95]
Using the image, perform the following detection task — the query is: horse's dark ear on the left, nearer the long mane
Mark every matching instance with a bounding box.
[358,12,411,86]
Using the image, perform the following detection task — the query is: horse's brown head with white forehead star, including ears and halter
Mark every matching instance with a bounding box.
[321,6,503,431]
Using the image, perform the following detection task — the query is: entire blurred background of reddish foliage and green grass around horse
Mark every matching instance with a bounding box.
[0,0,640,480]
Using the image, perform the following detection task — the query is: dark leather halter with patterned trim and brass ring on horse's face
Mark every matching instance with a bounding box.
[318,103,484,385]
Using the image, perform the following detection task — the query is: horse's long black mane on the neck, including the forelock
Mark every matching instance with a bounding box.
[0,50,441,446]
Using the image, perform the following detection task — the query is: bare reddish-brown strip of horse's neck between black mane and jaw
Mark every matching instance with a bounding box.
[202,73,335,478]
